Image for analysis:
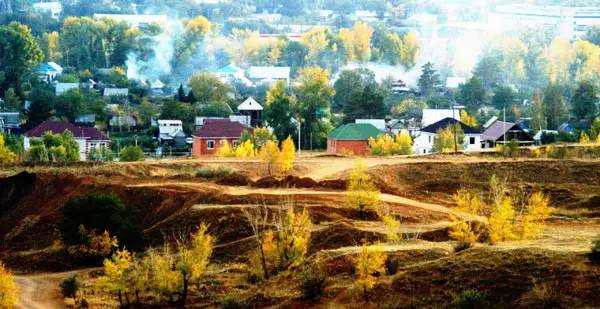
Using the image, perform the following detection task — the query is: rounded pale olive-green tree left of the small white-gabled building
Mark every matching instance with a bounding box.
[188,73,233,104]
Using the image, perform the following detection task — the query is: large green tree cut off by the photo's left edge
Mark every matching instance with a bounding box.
[0,22,44,96]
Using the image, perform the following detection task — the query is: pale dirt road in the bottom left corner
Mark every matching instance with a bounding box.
[15,272,77,309]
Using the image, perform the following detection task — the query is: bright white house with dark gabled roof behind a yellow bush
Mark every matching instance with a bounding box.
[413,117,481,154]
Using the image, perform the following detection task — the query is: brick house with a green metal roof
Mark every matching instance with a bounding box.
[327,123,383,155]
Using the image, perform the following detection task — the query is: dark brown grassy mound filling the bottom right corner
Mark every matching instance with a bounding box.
[386,247,600,307]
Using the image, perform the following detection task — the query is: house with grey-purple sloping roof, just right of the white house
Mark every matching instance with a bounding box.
[481,120,534,148]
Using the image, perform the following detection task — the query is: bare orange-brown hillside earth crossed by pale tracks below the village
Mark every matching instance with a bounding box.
[0,156,600,307]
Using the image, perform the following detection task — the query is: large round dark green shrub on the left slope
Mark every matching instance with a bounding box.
[59,193,143,249]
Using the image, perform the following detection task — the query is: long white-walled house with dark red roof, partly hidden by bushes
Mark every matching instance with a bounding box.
[24,120,110,161]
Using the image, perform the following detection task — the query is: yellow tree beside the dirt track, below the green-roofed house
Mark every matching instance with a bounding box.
[346,161,381,219]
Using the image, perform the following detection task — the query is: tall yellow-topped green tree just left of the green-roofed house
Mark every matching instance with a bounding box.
[296,67,335,147]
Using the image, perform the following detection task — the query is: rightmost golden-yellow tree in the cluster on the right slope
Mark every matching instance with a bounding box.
[518,192,552,239]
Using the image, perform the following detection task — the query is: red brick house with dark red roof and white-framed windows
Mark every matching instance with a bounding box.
[192,119,252,157]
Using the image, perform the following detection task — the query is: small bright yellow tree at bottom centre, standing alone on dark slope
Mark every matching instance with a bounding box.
[354,245,386,301]
